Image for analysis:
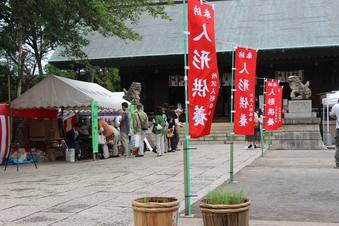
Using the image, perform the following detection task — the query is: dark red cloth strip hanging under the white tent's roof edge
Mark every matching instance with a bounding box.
[12,108,58,119]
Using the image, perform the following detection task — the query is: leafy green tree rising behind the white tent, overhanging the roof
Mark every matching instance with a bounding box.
[0,0,172,98]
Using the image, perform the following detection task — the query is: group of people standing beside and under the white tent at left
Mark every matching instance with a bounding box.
[65,102,183,161]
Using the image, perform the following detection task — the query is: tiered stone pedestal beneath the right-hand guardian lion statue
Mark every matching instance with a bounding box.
[272,100,327,150]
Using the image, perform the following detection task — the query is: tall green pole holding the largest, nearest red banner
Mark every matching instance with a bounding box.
[182,0,191,215]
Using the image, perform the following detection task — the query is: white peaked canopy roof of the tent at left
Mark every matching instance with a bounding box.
[11,75,126,110]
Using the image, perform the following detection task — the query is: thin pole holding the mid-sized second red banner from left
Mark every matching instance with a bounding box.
[228,44,235,182]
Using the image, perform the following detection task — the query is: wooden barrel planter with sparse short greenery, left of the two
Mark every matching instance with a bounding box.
[132,197,180,226]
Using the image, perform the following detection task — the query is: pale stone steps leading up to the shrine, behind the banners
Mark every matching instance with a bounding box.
[178,122,281,146]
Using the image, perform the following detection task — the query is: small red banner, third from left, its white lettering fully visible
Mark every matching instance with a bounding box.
[264,81,282,130]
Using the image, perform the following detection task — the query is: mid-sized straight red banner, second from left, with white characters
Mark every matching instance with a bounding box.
[234,48,257,135]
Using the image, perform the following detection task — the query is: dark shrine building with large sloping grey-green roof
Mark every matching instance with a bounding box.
[49,0,339,120]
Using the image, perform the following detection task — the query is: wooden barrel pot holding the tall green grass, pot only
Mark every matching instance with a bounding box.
[199,200,250,226]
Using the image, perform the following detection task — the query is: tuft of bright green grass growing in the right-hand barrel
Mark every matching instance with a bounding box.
[204,188,247,204]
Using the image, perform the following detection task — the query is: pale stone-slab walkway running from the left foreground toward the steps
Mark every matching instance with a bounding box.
[0,144,260,226]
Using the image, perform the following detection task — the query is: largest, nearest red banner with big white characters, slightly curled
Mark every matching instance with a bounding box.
[188,0,219,138]
